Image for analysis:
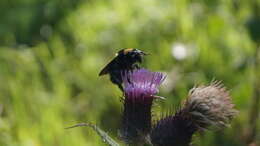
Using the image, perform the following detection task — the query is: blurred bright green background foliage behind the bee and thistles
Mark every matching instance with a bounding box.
[0,0,260,146]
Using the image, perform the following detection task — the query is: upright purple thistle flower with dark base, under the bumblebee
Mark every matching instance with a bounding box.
[120,69,165,143]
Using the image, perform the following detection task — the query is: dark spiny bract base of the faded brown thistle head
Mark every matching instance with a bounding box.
[150,111,197,146]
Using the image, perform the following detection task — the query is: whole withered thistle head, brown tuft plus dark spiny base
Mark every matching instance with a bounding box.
[150,82,237,146]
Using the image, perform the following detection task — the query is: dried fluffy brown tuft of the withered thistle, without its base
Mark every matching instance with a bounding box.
[183,82,237,129]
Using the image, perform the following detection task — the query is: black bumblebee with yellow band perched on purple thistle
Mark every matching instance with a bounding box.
[99,48,147,91]
